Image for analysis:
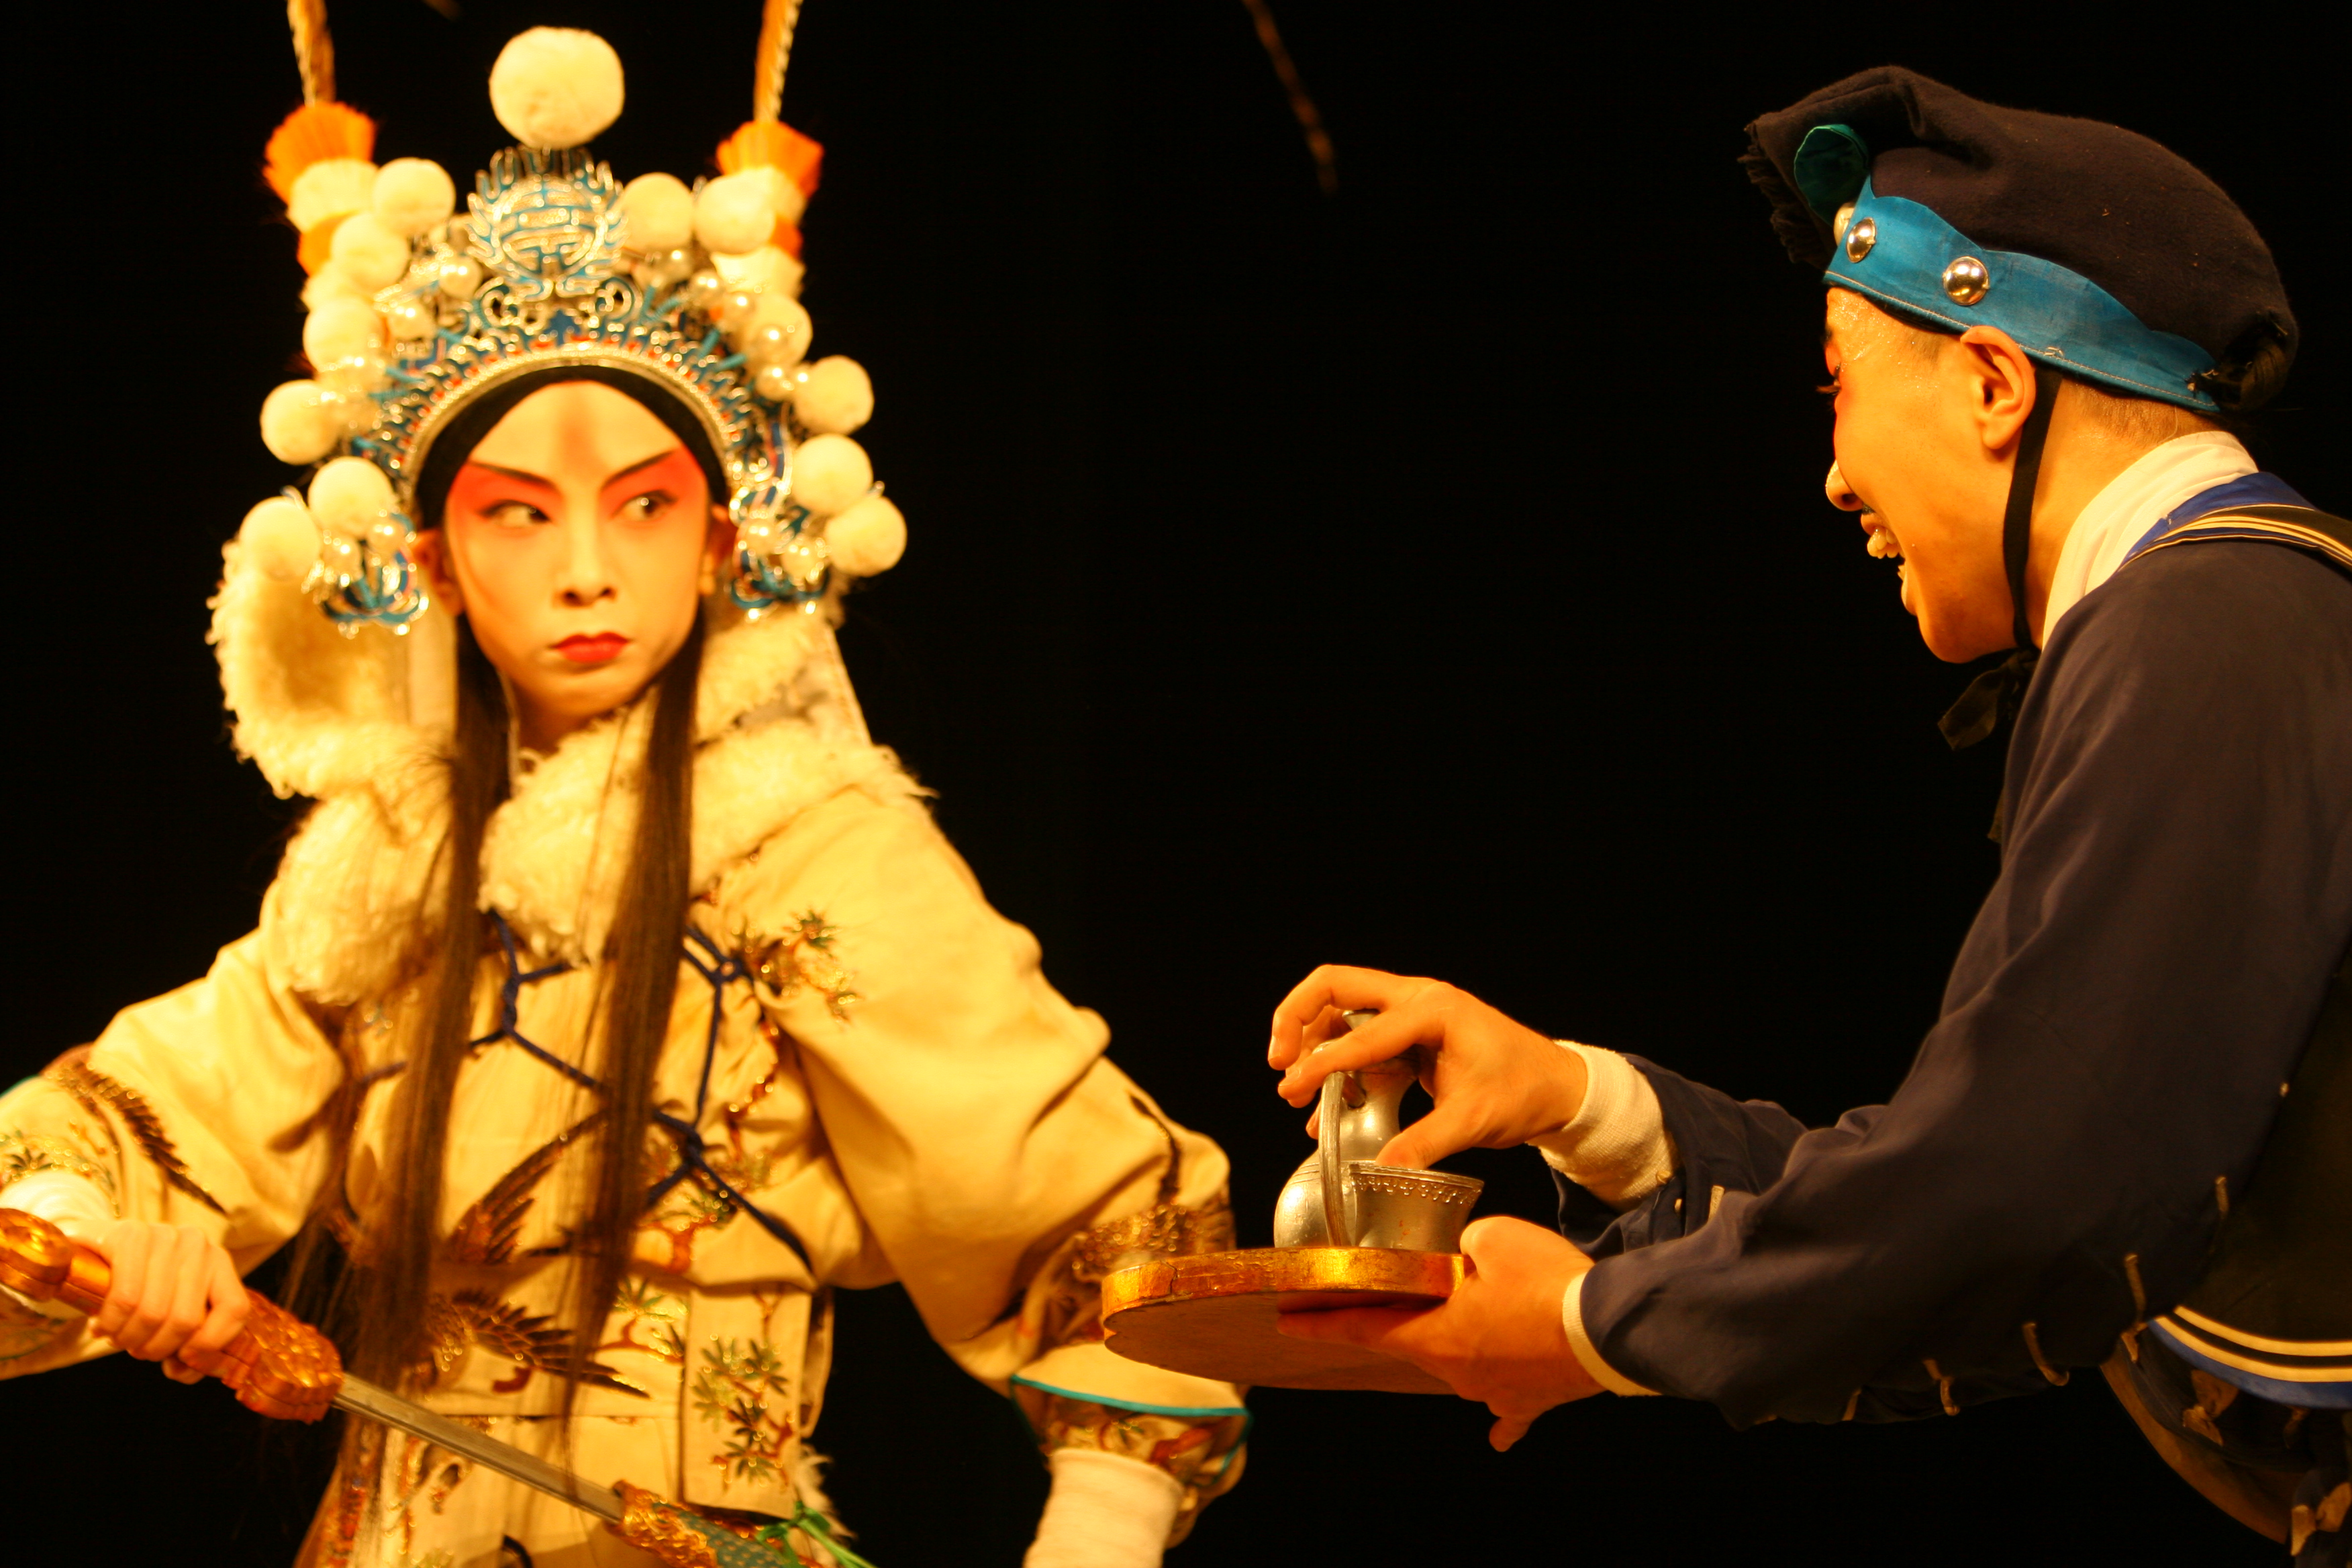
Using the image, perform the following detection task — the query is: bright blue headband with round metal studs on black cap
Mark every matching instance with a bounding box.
[1792,125,2220,413]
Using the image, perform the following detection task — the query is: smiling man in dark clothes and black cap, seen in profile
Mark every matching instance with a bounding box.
[1268,68,2352,1563]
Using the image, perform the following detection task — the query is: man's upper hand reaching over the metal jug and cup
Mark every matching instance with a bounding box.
[1265,964,1585,1166]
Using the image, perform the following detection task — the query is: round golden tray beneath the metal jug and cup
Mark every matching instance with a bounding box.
[1103,1246,1463,1394]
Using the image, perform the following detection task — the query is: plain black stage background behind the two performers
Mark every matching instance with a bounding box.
[0,0,2352,1568]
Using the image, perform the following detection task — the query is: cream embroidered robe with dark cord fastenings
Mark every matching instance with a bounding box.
[0,681,1246,1565]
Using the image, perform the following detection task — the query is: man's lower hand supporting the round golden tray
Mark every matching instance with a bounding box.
[1279,1218,1602,1453]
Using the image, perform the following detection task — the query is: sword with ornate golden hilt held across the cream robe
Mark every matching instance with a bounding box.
[0,1208,873,1568]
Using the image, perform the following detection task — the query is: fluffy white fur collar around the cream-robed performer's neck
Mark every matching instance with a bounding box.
[211,543,920,1006]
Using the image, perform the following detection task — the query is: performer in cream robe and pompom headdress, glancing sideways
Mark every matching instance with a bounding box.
[0,28,1246,1568]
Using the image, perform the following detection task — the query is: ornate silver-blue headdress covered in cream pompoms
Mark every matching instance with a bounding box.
[238,0,905,635]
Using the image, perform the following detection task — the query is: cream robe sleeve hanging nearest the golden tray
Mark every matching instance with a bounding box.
[722,792,1246,1535]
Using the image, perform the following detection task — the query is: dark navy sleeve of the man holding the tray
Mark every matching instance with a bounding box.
[1567,543,2352,1424]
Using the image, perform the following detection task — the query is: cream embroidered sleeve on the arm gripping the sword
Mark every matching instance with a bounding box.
[0,895,346,1377]
